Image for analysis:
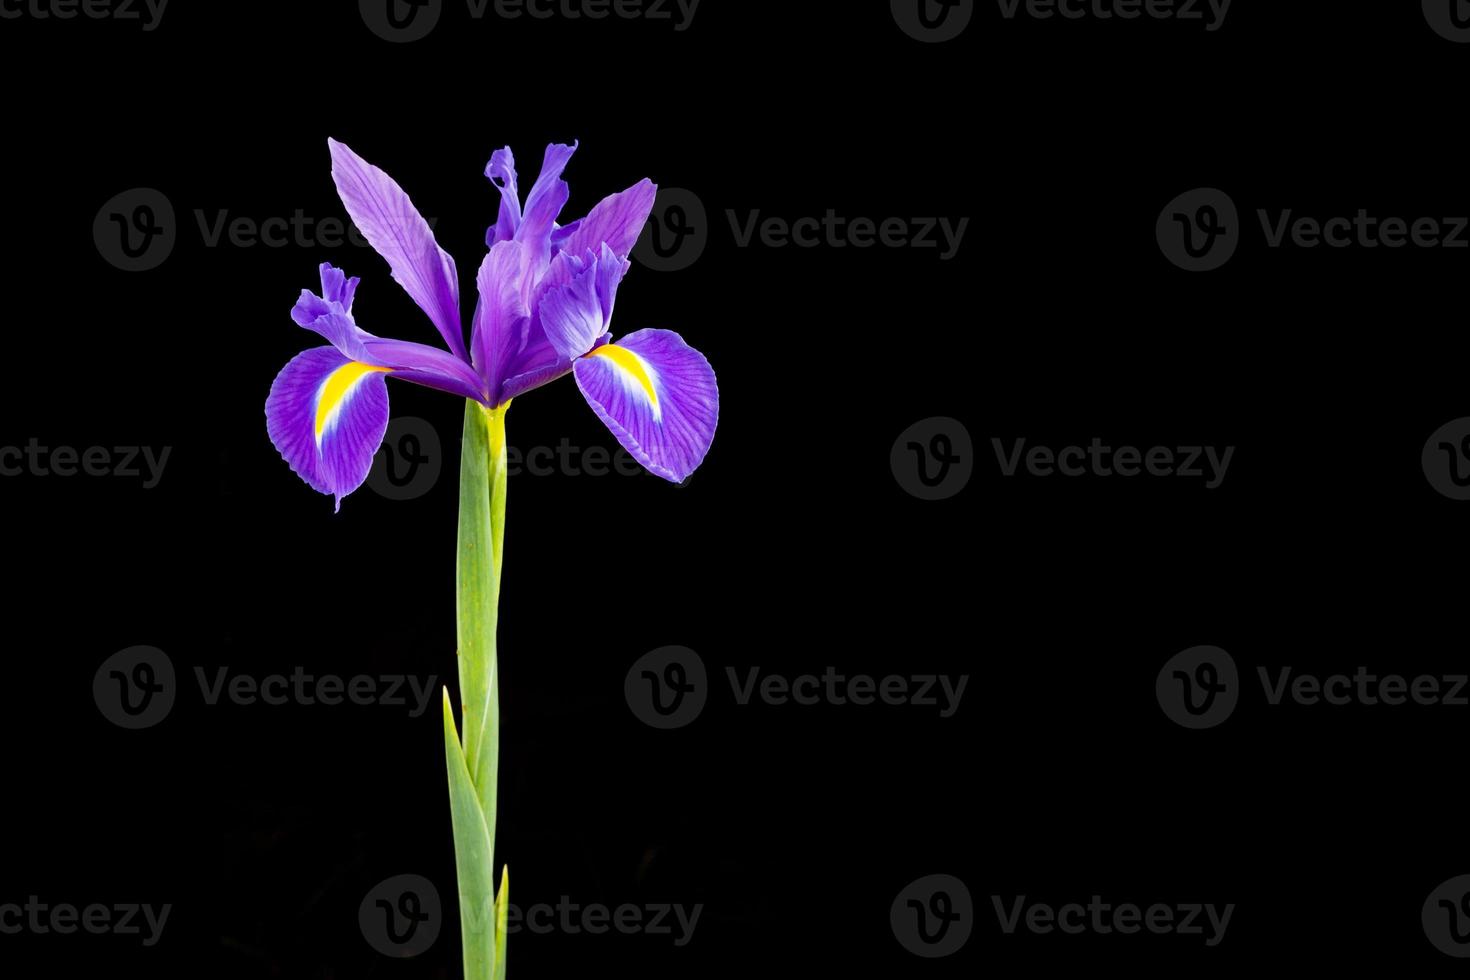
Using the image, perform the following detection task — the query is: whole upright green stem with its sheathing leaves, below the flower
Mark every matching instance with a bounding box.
[444,401,510,980]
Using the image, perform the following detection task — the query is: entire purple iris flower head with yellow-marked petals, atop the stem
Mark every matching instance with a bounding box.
[266,140,719,508]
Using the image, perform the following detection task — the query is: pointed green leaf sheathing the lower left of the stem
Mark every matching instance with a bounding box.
[444,688,506,980]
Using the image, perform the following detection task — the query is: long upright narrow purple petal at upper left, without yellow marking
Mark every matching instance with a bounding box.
[326,140,467,360]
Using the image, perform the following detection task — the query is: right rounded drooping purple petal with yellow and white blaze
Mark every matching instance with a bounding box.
[573,331,720,483]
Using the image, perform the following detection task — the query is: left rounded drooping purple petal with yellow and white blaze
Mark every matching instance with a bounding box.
[266,347,388,510]
